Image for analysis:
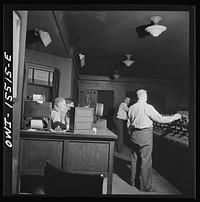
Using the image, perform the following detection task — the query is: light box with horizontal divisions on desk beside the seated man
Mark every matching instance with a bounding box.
[74,107,94,132]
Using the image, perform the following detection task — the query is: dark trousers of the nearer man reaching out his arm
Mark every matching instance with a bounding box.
[131,128,153,190]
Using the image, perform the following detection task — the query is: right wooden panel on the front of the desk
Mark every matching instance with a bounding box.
[64,140,110,173]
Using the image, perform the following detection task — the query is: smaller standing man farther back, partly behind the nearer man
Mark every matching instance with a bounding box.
[116,97,130,153]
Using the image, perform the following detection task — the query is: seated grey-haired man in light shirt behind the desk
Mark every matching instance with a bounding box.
[51,97,68,130]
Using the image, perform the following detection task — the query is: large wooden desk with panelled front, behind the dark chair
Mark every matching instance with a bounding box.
[18,129,117,194]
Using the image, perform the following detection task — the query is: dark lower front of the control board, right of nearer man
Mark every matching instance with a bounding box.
[152,134,194,196]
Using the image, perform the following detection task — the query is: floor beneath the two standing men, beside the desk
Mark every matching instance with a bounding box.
[103,145,182,197]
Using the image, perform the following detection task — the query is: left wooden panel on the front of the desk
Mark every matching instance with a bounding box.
[20,139,63,171]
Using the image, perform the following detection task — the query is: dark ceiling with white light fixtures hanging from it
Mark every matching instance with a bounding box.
[27,7,190,80]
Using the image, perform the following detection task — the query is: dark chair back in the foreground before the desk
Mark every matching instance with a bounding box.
[44,160,103,197]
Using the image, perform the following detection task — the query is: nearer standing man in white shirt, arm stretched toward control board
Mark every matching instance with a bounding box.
[128,89,181,192]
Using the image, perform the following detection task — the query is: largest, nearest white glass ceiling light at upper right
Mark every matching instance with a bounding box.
[145,16,167,37]
